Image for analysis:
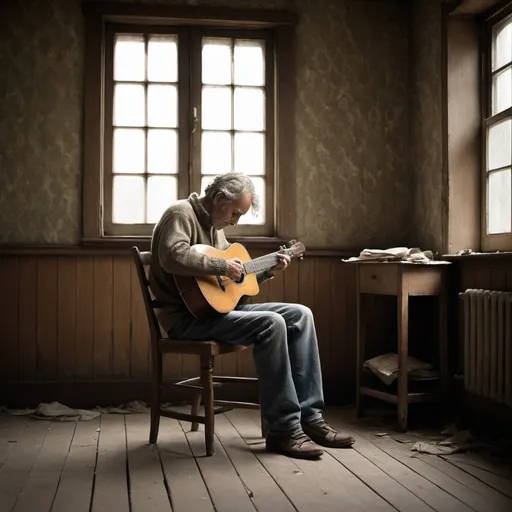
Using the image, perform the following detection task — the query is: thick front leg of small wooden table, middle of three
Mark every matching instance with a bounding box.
[397,284,409,432]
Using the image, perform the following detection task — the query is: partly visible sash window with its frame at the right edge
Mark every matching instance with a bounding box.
[482,12,512,250]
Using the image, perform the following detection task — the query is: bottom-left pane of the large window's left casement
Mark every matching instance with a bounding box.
[112,176,144,224]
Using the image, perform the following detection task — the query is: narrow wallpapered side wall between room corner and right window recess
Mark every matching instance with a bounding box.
[410,0,447,254]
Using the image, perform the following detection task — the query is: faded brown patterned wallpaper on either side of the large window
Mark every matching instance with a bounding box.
[0,0,420,249]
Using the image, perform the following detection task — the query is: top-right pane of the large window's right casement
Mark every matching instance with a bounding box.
[234,40,265,85]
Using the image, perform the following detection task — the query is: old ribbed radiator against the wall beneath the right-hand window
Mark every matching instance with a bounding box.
[460,289,512,407]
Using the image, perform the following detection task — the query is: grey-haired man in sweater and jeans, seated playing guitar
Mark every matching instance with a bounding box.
[150,173,354,458]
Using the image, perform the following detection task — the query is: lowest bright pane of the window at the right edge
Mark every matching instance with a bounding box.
[487,169,512,234]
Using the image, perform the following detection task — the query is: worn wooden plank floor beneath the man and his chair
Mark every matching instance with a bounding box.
[0,410,512,512]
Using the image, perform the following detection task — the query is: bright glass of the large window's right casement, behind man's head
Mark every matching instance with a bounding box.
[201,37,266,225]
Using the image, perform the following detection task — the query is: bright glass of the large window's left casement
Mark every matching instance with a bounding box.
[112,34,178,224]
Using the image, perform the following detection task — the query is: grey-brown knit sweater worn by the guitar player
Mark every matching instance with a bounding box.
[149,193,272,336]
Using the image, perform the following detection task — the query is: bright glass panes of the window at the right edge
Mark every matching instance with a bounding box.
[486,19,512,234]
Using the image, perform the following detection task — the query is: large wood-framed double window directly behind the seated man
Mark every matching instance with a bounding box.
[83,4,295,241]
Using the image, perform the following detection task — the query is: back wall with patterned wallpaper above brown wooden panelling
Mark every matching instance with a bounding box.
[0,0,426,405]
